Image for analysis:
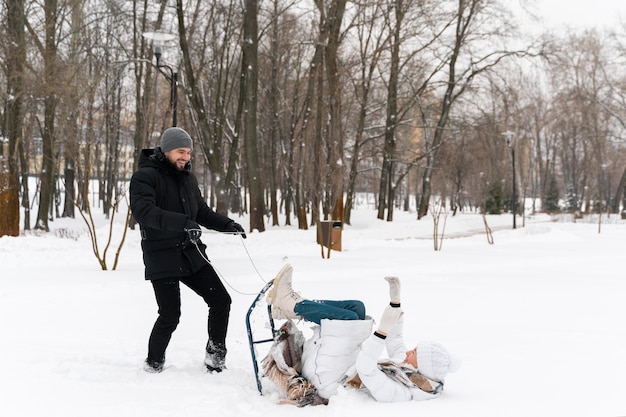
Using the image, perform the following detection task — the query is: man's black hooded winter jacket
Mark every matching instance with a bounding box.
[130,148,233,280]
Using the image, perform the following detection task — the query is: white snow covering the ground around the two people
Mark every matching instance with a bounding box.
[0,206,626,417]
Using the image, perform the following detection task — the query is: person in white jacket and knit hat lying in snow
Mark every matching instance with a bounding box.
[264,265,460,406]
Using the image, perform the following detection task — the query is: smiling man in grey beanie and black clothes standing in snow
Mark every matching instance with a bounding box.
[130,127,246,373]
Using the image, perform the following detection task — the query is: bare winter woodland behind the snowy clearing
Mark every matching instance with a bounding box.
[0,0,626,236]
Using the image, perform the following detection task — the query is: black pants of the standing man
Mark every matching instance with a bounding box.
[148,265,231,361]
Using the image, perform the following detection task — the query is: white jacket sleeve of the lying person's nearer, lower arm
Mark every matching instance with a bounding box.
[356,335,413,402]
